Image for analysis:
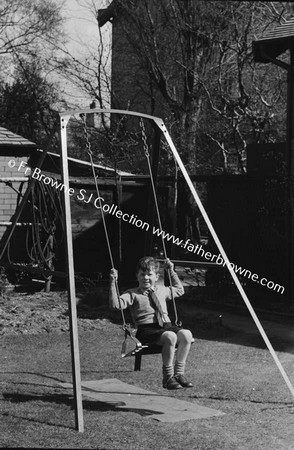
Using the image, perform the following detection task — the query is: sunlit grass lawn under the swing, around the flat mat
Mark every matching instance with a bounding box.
[0,290,294,450]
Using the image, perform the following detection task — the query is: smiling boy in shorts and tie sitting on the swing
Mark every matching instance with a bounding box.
[109,256,193,389]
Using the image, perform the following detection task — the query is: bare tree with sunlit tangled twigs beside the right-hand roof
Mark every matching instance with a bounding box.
[201,2,291,171]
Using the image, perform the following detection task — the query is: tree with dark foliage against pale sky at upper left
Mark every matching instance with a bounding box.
[0,0,64,146]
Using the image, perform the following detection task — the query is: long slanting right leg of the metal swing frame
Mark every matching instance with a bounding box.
[155,119,294,398]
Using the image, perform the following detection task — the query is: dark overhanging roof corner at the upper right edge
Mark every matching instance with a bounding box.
[252,17,294,63]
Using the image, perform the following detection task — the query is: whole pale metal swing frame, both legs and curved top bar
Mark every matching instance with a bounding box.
[59,108,294,432]
